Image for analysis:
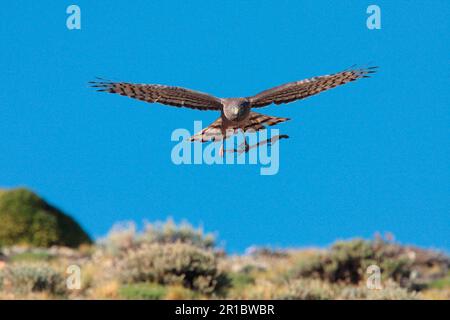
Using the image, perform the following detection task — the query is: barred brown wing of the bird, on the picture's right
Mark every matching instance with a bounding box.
[248,67,377,108]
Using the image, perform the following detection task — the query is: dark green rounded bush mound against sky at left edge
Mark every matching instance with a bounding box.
[0,189,91,247]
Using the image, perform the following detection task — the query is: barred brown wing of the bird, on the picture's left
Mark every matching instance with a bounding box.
[89,81,222,110]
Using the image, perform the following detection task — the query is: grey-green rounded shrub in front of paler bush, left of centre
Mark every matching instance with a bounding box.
[115,243,229,294]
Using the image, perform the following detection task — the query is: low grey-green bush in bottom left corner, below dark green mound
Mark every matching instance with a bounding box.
[0,264,66,296]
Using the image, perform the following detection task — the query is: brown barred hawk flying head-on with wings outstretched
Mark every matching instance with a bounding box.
[89,67,377,155]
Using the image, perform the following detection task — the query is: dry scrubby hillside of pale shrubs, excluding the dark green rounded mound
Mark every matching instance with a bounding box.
[0,220,450,300]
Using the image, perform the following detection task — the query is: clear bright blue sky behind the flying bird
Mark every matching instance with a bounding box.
[0,0,450,251]
